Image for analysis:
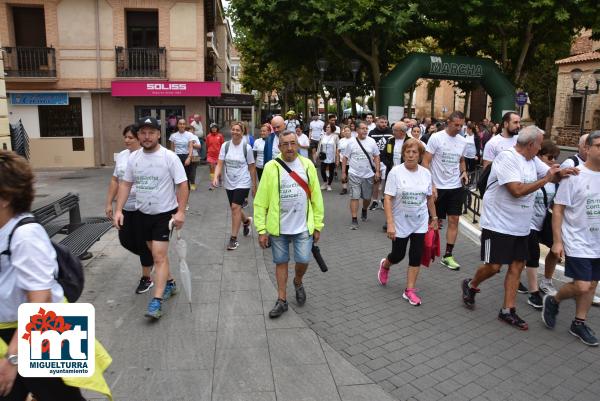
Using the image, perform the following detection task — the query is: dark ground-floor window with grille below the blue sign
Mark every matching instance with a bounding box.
[38,97,83,138]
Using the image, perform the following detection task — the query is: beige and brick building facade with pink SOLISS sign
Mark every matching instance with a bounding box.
[0,0,231,168]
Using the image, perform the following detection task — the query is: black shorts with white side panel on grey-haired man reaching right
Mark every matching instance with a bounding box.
[481,228,528,265]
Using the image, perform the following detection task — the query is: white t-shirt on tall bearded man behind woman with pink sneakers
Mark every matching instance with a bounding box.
[426,130,467,189]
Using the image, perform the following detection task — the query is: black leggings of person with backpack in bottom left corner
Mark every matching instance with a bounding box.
[0,329,85,401]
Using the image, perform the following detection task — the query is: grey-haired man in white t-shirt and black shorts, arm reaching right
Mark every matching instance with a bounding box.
[462,125,572,330]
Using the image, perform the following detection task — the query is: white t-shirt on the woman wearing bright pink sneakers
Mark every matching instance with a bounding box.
[384,163,432,238]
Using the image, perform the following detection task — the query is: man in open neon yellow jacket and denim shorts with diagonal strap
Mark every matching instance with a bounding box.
[254,131,324,319]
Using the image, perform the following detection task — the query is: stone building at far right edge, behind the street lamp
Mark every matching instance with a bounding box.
[551,31,600,146]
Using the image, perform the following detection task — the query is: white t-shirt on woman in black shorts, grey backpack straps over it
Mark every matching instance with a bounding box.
[219,141,254,190]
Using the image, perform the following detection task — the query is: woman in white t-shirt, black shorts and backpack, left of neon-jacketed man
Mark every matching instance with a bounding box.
[213,121,256,251]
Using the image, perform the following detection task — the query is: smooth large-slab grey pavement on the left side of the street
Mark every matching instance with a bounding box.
[37,168,393,401]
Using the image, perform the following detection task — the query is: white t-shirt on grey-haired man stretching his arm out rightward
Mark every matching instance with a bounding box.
[481,148,549,236]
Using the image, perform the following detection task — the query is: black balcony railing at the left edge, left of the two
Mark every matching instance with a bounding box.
[2,46,56,78]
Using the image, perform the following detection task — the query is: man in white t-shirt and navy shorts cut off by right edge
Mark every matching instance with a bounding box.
[542,131,600,346]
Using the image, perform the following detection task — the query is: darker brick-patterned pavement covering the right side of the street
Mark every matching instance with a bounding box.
[263,182,600,401]
